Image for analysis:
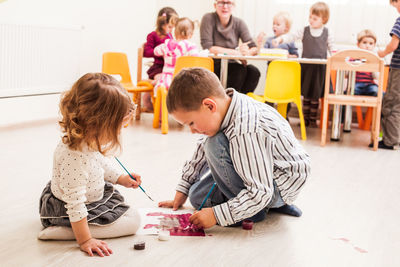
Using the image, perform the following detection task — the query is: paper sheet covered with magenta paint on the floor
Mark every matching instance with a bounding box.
[145,212,206,236]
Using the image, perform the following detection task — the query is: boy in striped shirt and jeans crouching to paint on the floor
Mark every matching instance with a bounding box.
[159,68,310,228]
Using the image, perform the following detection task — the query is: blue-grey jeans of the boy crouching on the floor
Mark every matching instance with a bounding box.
[189,132,285,222]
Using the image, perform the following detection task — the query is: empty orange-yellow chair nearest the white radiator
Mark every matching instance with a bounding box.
[102,51,154,120]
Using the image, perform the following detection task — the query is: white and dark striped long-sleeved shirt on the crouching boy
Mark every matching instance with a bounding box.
[176,89,310,226]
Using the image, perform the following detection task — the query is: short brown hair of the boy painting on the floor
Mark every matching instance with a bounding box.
[167,68,226,113]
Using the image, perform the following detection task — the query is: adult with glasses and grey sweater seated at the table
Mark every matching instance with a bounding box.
[200,0,260,94]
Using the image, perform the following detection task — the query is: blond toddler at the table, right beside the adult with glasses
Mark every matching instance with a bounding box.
[257,12,299,57]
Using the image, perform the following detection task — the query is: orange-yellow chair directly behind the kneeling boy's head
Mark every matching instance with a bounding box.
[153,56,214,134]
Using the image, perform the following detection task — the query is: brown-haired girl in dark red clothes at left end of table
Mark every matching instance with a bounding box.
[143,7,178,111]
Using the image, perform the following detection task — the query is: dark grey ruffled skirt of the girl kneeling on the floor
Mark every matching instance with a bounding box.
[39,182,129,227]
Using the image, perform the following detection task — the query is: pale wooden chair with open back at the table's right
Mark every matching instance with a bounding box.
[321,50,384,150]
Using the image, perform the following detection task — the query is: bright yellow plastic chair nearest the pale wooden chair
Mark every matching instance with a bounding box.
[247,60,307,140]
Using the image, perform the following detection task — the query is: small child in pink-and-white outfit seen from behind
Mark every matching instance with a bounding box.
[154,18,199,94]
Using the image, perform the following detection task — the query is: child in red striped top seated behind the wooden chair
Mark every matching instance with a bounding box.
[354,30,378,96]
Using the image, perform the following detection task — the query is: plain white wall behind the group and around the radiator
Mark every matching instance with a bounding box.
[0,0,397,126]
